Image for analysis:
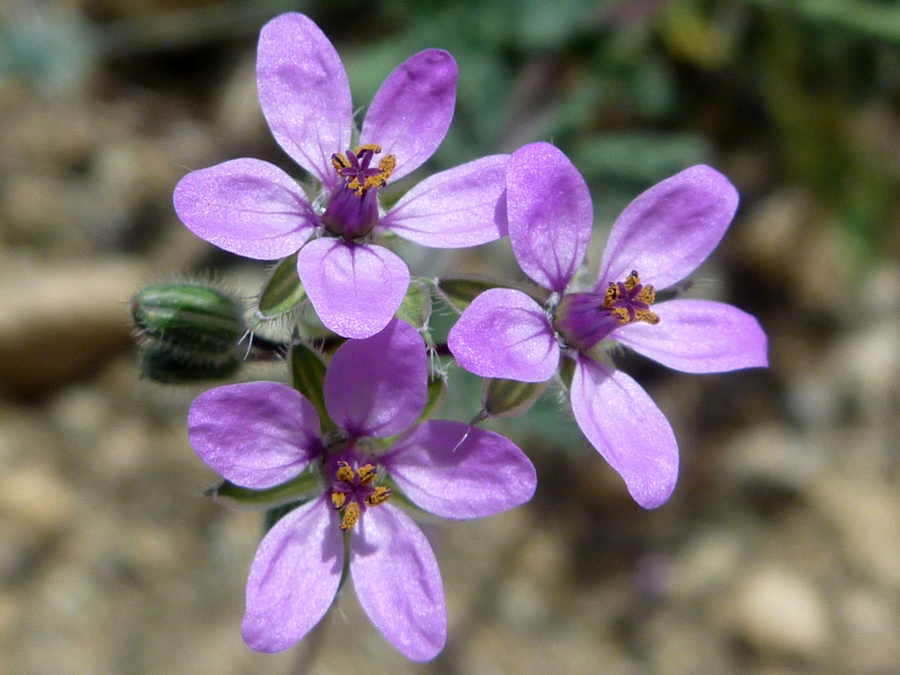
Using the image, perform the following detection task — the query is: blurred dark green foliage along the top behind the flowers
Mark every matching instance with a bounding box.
[0,0,900,258]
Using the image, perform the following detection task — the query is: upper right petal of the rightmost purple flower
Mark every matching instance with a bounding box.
[597,164,738,292]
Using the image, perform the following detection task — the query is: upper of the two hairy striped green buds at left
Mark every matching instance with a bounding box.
[131,282,247,357]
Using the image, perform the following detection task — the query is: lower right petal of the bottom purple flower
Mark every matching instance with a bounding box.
[350,504,447,661]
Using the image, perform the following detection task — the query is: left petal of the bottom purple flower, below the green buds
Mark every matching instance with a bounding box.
[188,382,321,489]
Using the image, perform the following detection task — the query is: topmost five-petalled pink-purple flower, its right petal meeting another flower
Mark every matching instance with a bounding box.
[174,13,509,338]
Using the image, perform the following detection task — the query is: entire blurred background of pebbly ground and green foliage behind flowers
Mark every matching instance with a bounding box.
[0,0,900,675]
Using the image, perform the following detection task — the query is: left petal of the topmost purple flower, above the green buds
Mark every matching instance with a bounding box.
[173,159,316,260]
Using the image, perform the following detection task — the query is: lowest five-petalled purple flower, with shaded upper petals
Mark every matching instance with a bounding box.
[188,320,537,661]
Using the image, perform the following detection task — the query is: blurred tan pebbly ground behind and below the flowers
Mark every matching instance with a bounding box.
[0,2,900,675]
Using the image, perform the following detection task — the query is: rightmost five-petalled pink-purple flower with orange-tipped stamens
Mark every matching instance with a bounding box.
[448,143,768,508]
